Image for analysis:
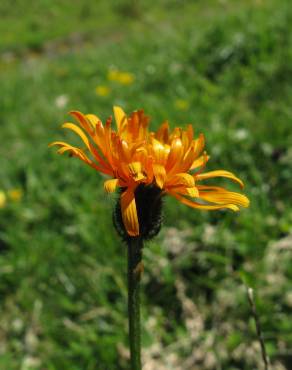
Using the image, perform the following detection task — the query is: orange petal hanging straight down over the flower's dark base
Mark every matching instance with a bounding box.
[121,188,139,236]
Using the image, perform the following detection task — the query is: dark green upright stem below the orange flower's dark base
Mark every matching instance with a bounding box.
[128,238,143,370]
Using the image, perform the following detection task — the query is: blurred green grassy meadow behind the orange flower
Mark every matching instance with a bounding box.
[0,0,292,370]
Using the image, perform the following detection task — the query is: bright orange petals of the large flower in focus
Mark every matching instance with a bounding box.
[50,107,249,236]
